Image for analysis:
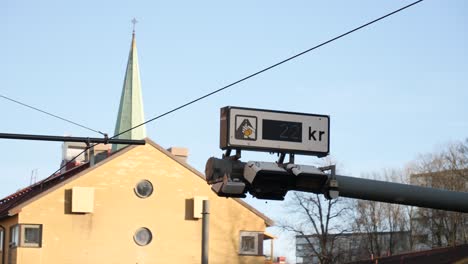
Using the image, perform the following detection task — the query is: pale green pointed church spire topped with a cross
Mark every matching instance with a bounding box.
[112,25,146,152]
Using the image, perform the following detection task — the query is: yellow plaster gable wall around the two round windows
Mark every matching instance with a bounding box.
[13,144,265,264]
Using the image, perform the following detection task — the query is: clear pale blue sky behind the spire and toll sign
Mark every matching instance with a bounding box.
[0,0,468,261]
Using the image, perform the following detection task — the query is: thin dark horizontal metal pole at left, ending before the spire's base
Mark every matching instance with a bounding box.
[0,133,146,145]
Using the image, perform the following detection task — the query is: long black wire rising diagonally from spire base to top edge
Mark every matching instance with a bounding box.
[111,0,424,138]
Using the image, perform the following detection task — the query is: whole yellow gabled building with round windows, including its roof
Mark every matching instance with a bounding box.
[0,139,272,264]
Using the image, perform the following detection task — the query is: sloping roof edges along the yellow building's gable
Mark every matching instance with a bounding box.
[0,138,274,226]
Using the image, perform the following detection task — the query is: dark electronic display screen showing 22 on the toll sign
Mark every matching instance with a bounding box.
[262,119,302,142]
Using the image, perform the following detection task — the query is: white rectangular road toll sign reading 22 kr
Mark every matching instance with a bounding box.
[220,106,330,156]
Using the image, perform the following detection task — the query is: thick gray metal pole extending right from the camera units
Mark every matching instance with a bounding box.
[336,175,468,213]
